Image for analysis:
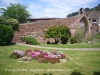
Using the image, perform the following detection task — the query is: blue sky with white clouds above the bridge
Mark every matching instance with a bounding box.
[0,0,100,18]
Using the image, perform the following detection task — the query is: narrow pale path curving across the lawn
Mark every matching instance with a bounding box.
[16,43,100,50]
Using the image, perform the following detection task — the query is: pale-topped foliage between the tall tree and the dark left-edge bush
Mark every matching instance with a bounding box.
[0,17,19,31]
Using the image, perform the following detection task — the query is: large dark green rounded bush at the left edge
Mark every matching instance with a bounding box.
[0,24,14,46]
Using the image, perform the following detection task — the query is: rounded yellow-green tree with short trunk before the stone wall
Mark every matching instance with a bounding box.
[45,25,71,44]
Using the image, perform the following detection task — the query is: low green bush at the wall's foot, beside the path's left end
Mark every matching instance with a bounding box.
[21,36,40,45]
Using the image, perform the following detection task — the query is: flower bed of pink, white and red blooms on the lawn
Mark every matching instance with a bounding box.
[10,49,66,64]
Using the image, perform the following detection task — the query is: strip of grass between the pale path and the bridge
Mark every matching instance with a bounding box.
[41,43,100,48]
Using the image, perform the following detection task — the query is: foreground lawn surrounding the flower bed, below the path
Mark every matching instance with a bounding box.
[0,45,100,75]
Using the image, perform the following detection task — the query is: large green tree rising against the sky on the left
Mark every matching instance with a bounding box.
[2,3,31,23]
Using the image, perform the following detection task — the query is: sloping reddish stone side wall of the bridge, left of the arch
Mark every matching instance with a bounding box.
[13,15,91,43]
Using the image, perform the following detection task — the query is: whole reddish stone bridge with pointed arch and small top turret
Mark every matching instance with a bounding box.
[13,8,100,43]
